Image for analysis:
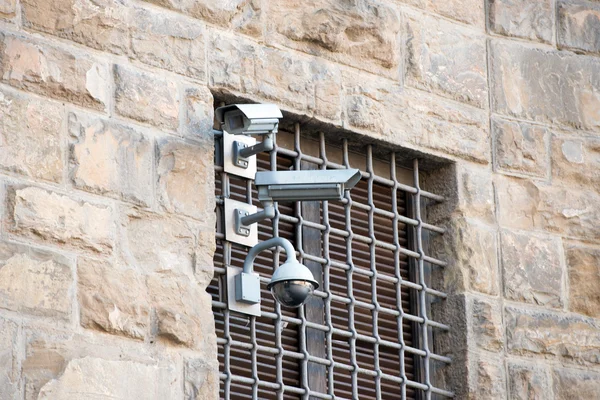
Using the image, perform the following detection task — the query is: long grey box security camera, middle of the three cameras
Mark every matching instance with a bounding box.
[254,169,361,202]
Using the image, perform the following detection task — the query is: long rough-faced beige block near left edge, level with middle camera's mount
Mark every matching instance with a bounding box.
[10,187,115,253]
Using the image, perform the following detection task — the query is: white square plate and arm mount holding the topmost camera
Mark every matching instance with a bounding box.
[223,131,255,179]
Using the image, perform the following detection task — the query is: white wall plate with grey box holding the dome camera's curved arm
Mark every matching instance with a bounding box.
[227,267,261,317]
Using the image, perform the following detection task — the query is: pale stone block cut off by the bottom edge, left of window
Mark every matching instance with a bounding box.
[38,357,183,400]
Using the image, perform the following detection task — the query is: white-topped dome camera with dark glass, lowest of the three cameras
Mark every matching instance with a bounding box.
[267,260,319,308]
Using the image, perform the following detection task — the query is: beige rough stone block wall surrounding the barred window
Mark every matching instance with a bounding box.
[0,0,600,400]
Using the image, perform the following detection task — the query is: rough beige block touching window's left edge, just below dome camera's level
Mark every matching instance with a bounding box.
[147,271,216,354]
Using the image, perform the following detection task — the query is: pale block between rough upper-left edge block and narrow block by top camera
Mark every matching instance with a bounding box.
[114,65,179,131]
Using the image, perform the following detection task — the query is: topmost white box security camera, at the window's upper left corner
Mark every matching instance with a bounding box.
[215,104,283,135]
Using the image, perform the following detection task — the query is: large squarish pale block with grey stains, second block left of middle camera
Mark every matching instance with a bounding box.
[69,113,155,206]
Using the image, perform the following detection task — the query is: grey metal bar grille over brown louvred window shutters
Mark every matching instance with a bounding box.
[208,124,452,400]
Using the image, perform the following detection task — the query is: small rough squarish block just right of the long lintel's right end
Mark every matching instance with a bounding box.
[492,118,550,178]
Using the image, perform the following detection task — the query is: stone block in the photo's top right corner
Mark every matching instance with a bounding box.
[556,0,600,54]
